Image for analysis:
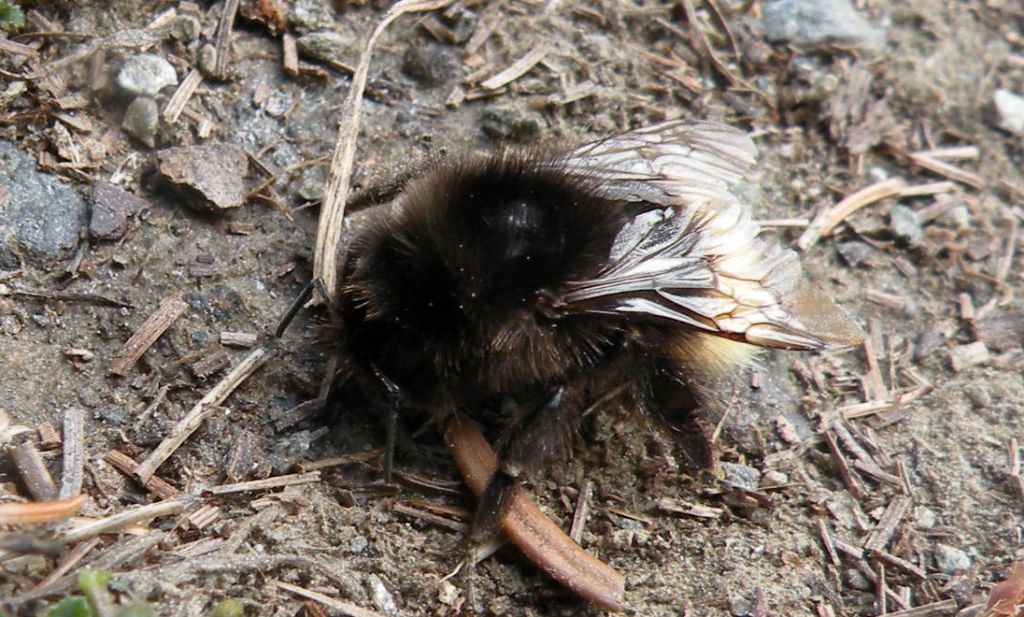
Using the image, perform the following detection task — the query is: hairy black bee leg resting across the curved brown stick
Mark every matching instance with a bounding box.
[469,387,581,544]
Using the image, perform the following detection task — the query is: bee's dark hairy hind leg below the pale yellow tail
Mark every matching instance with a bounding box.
[632,351,715,472]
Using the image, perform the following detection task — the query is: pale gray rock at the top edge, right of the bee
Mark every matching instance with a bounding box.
[762,0,886,49]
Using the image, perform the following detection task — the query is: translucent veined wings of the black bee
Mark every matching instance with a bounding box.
[560,122,862,349]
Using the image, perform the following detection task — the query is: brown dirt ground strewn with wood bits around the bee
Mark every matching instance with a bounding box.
[0,0,1024,617]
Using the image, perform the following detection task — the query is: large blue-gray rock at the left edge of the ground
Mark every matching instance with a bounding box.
[0,141,88,268]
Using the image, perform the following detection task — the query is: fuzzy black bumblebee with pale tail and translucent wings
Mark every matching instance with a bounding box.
[323,122,860,536]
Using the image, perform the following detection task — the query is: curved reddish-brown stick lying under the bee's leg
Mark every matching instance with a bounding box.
[445,415,626,612]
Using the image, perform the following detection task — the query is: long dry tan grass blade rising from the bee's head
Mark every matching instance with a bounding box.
[313,0,453,302]
